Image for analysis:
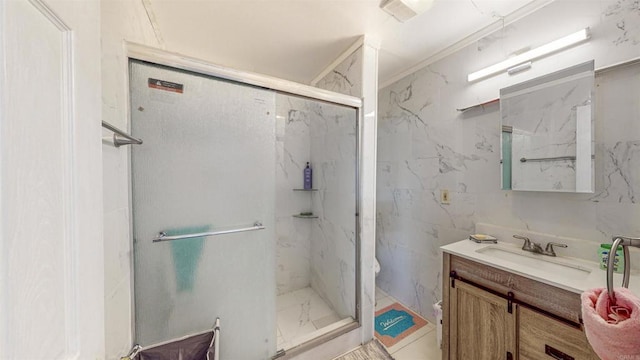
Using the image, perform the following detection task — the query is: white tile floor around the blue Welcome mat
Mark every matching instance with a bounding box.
[376,288,442,360]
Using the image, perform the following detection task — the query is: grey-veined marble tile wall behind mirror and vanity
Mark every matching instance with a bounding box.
[376,0,640,320]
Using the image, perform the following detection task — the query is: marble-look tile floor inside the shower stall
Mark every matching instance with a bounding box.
[276,287,353,349]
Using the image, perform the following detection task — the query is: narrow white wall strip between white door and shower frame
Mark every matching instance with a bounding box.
[101,0,160,359]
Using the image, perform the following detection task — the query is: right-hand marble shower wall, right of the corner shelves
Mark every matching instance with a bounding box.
[308,102,357,317]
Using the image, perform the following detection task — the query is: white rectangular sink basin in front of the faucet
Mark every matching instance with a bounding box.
[476,245,591,281]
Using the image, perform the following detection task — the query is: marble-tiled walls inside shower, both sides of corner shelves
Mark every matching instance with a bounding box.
[276,94,356,316]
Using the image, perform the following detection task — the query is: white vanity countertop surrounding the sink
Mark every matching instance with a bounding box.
[441,239,640,295]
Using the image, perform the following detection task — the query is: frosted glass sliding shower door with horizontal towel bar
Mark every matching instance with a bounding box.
[130,61,275,360]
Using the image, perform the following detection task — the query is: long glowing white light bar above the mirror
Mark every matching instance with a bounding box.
[467,28,590,82]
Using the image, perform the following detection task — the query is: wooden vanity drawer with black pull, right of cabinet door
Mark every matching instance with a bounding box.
[518,306,599,360]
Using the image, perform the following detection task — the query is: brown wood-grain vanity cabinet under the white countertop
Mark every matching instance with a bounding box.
[442,253,599,360]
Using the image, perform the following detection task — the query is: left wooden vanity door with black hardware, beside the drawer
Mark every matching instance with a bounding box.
[450,281,516,360]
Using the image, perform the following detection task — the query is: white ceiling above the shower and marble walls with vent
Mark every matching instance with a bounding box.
[150,0,549,84]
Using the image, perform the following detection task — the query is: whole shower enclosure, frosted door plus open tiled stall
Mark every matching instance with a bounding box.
[130,60,358,360]
